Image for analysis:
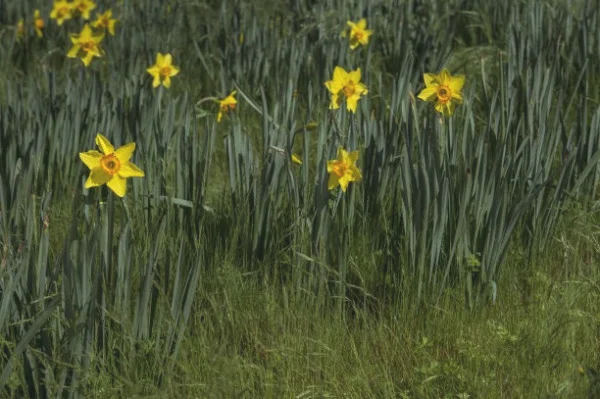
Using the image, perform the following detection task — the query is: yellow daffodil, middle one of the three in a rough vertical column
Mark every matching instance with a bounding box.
[325,66,369,112]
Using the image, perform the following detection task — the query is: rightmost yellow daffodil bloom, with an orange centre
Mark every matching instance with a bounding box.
[418,69,465,116]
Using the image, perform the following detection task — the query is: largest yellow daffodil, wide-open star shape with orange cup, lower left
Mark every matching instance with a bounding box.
[79,133,144,197]
